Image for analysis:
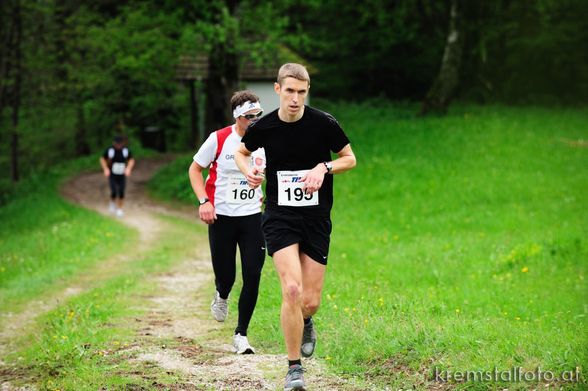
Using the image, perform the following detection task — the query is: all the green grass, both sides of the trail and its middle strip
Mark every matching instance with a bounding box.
[0,102,588,390]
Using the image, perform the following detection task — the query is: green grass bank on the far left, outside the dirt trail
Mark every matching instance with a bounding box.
[0,158,136,310]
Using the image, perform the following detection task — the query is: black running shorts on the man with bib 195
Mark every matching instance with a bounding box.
[261,210,332,265]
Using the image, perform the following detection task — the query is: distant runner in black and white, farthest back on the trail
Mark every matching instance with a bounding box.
[100,135,135,217]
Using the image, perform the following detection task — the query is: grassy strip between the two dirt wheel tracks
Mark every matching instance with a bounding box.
[8,213,203,390]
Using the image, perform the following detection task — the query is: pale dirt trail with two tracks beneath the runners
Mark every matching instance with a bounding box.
[0,159,365,390]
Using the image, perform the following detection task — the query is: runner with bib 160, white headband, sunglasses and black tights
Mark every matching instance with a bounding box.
[188,90,265,354]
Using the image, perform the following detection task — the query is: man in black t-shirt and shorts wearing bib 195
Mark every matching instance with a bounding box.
[235,64,355,390]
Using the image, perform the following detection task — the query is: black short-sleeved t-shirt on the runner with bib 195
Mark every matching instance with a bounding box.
[241,106,349,216]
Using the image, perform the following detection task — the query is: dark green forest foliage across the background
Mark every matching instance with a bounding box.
[0,0,588,184]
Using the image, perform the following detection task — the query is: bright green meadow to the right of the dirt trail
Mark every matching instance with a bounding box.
[152,104,588,389]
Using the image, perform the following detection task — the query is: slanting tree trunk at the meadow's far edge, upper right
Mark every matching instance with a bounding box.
[420,0,464,115]
